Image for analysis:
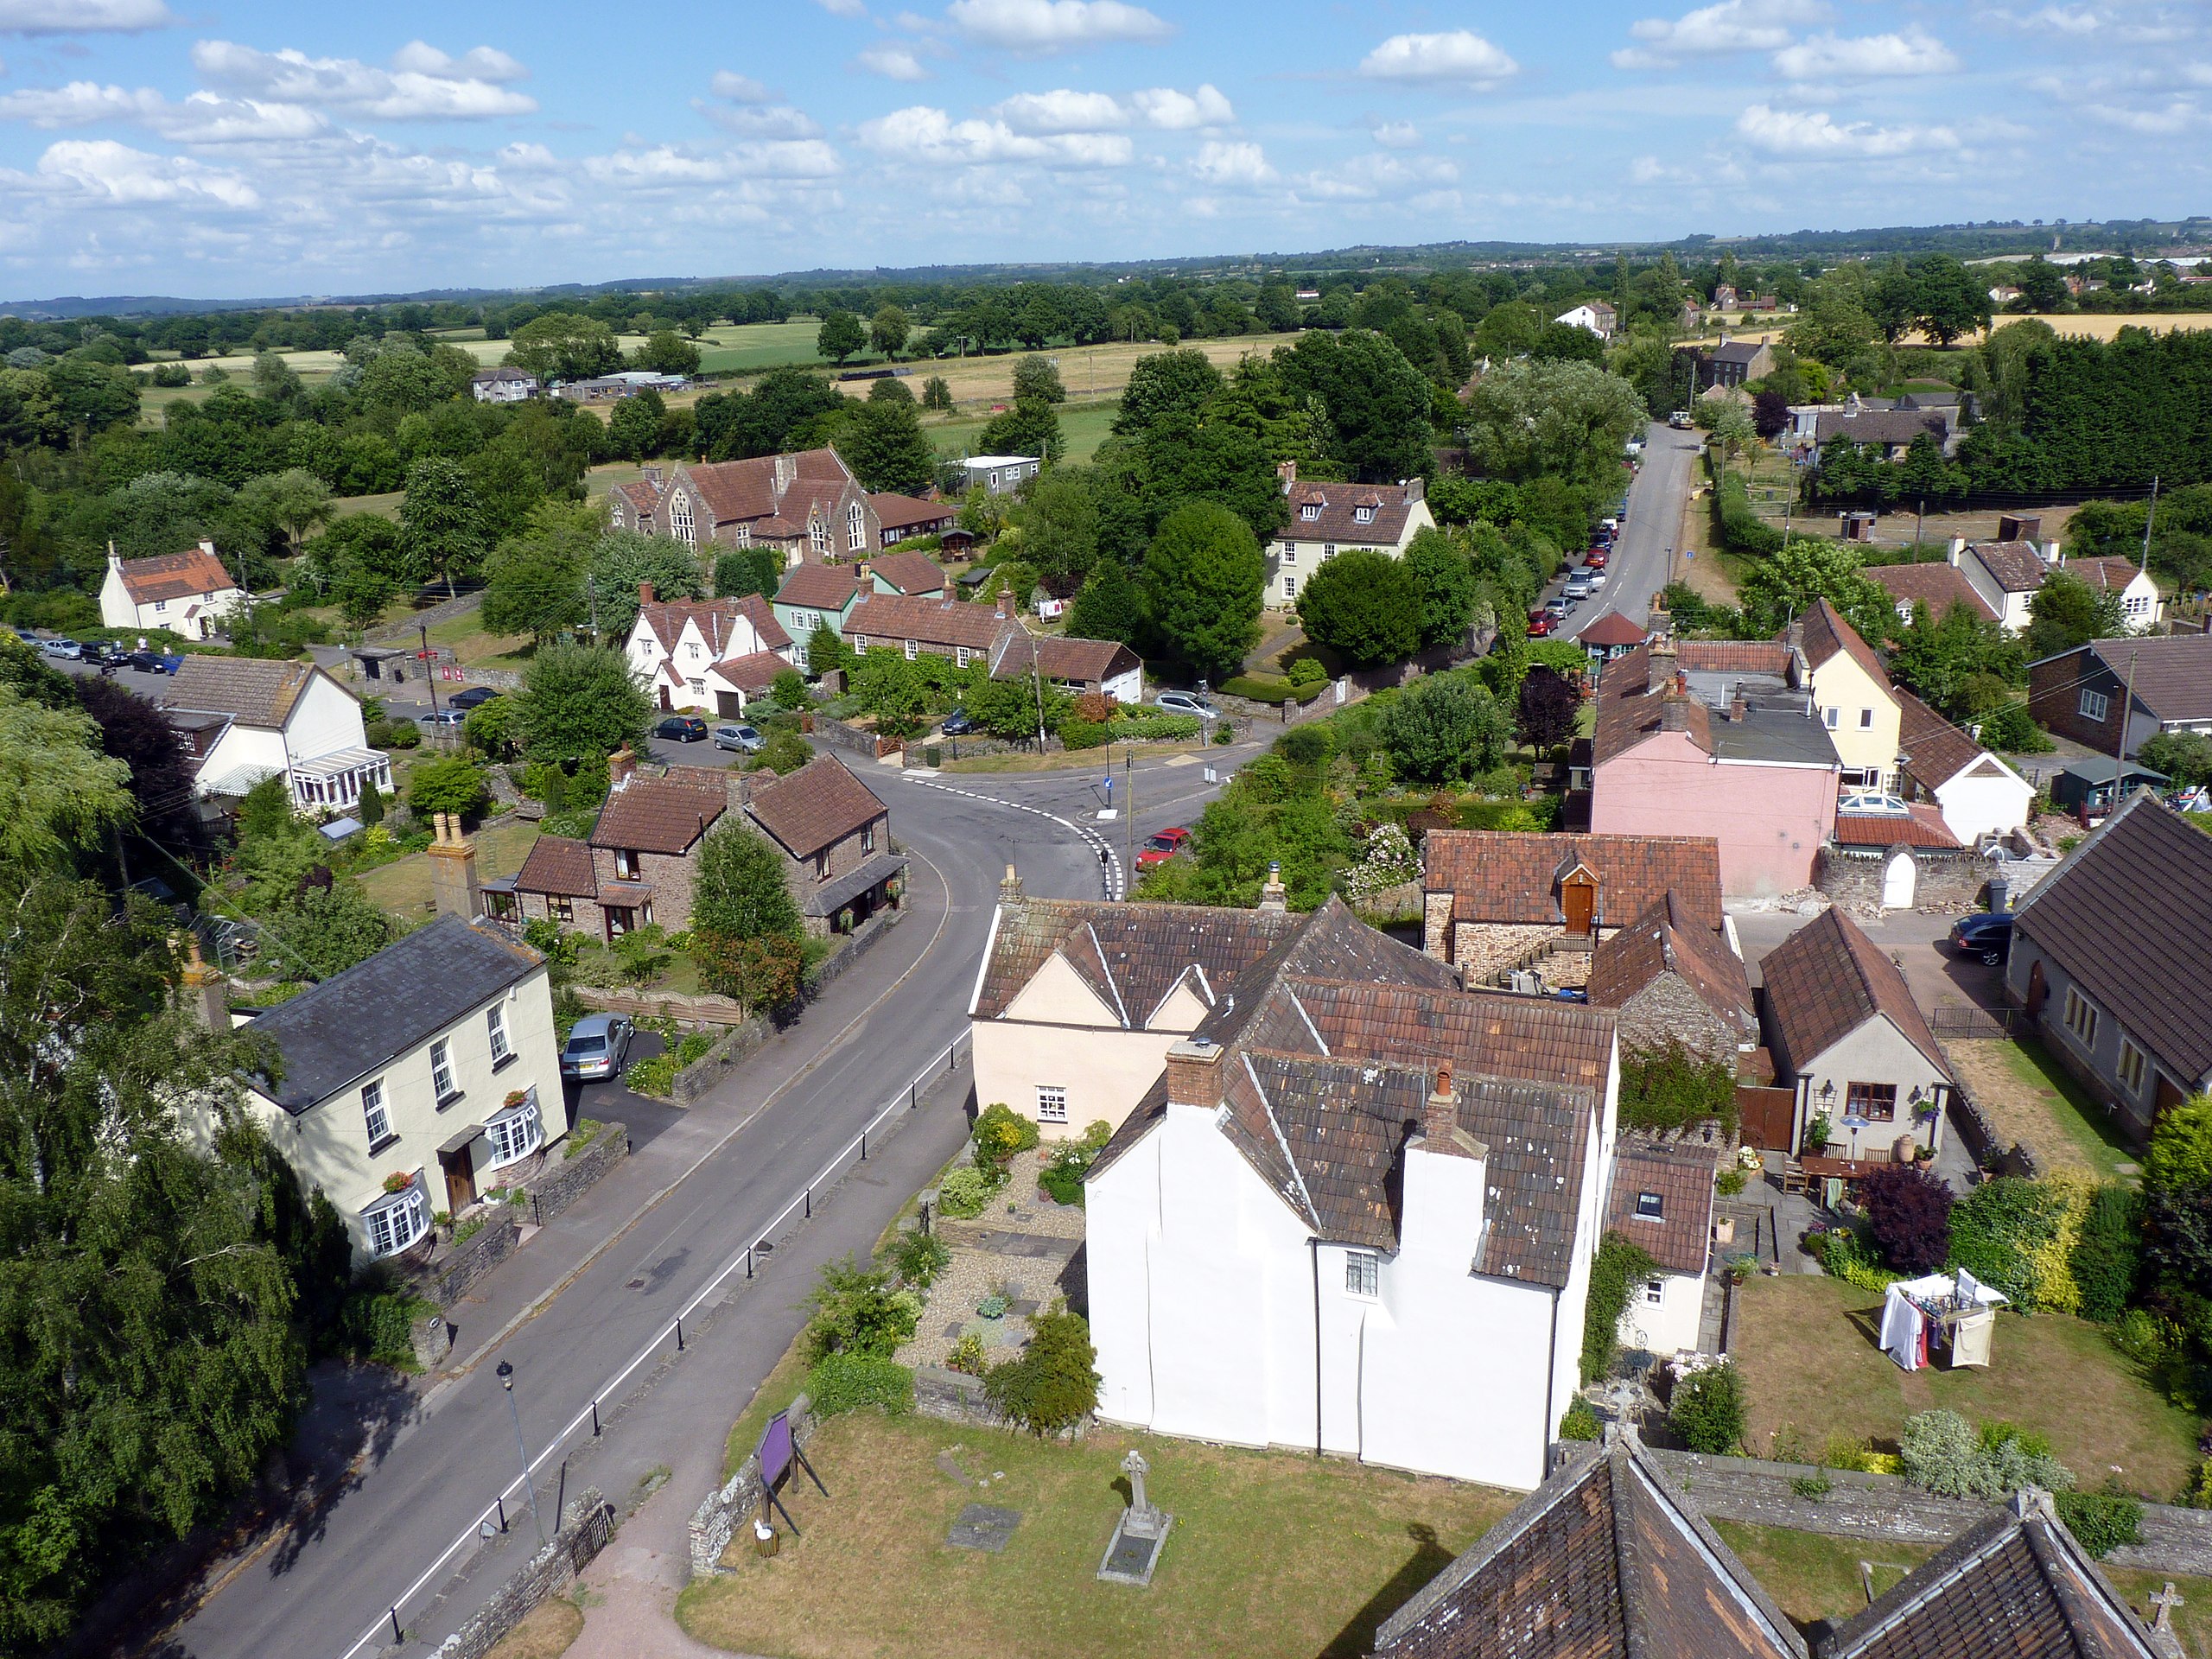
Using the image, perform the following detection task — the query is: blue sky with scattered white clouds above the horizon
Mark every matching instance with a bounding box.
[0,0,2212,299]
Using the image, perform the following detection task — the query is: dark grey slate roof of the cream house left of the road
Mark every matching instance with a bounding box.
[252,916,544,1110]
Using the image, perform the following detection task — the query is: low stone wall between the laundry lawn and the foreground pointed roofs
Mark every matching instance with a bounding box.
[1652,1449,2212,1577]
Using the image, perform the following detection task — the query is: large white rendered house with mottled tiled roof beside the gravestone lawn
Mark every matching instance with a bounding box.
[1086,973,1619,1491]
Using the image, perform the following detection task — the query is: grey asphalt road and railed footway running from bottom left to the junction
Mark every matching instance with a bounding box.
[157,746,1256,1659]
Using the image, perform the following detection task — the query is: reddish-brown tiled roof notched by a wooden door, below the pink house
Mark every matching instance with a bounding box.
[1421,830,1721,929]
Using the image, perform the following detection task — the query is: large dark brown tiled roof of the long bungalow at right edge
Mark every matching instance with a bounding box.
[2013,791,2212,1086]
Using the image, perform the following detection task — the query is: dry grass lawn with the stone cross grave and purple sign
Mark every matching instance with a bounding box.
[677,1414,1516,1659]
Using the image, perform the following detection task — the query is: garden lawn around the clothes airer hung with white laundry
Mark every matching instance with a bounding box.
[1737,1274,2196,1502]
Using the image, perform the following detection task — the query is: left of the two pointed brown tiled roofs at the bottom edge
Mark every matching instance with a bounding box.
[1374,1435,1805,1659]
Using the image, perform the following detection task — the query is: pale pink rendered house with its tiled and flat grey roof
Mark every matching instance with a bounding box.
[1577,639,1842,898]
